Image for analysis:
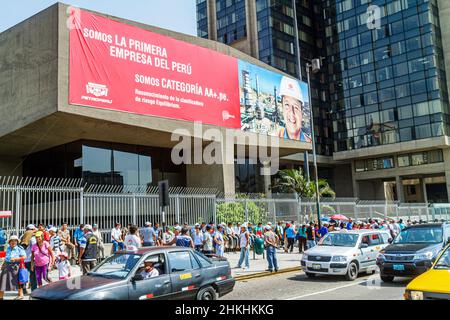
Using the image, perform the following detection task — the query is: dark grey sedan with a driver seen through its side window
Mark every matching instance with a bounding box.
[31,247,235,300]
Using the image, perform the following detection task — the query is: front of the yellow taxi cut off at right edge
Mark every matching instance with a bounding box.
[403,243,450,300]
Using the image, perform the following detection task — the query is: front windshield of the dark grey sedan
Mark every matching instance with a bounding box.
[89,253,142,279]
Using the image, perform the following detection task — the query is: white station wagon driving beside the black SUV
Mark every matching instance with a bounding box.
[301,229,392,280]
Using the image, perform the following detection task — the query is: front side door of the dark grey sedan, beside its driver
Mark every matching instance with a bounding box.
[128,253,172,300]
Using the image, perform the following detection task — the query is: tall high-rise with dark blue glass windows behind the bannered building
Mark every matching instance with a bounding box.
[197,0,450,202]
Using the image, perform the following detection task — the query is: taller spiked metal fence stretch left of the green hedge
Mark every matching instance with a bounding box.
[0,177,216,239]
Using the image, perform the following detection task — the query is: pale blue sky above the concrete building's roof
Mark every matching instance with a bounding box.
[0,0,197,35]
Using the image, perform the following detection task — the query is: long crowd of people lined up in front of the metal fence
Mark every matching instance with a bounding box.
[0,219,442,300]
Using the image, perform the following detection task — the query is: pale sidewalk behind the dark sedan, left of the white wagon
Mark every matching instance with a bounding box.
[225,248,302,279]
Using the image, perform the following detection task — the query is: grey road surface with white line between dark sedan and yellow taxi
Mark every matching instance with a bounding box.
[222,271,411,300]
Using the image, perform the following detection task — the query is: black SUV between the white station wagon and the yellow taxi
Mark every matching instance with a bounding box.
[377,222,450,282]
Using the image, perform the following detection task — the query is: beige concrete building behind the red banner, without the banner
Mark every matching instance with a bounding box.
[0,3,311,194]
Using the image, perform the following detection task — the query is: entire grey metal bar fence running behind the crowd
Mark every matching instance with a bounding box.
[0,177,450,236]
